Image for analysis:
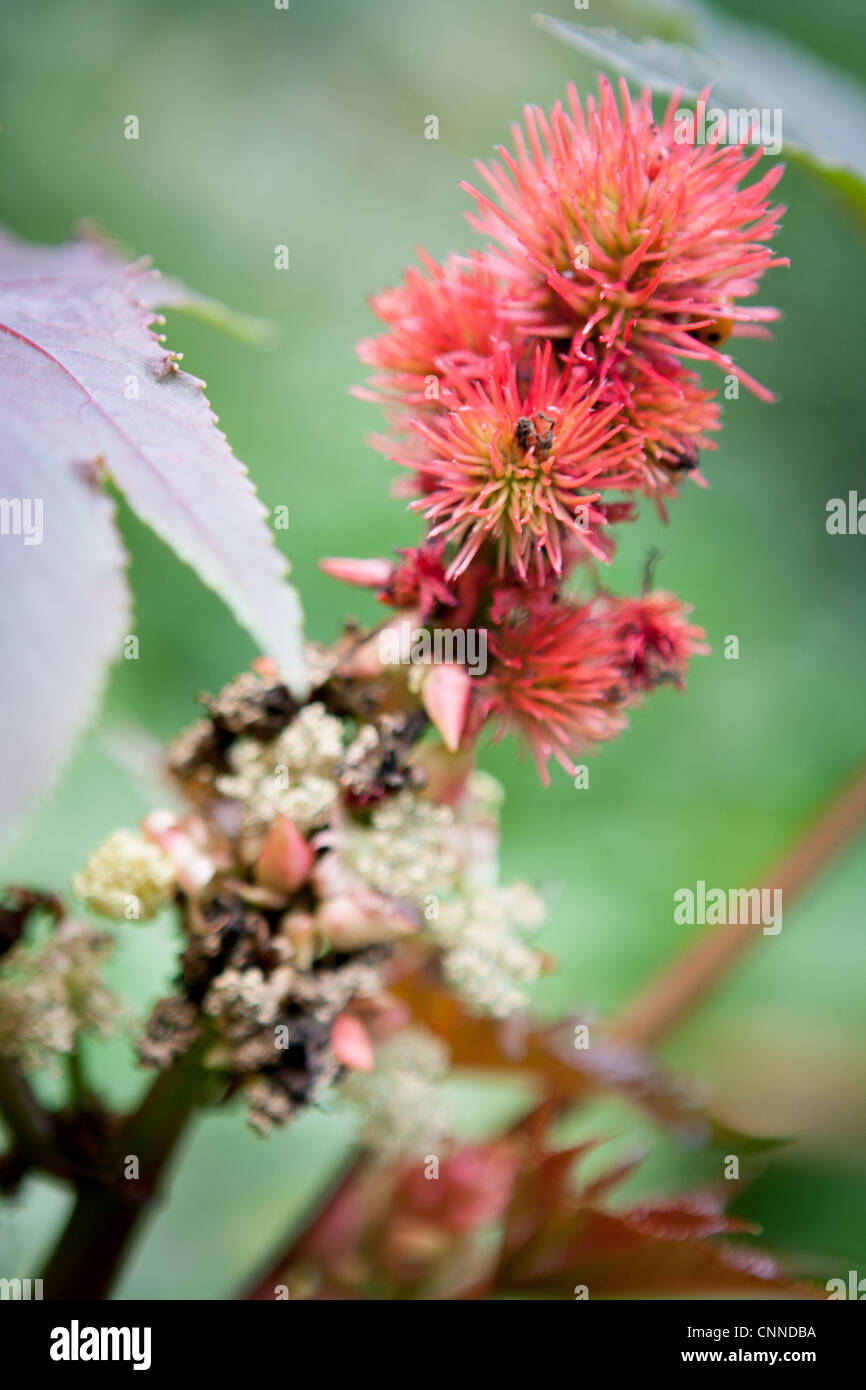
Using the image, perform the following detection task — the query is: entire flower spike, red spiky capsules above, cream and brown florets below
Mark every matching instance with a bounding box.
[6,82,777,1154]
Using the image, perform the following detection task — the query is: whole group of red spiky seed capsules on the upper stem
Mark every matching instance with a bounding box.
[324,79,783,780]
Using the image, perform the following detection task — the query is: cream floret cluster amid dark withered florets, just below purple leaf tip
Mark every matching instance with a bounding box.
[217,705,343,831]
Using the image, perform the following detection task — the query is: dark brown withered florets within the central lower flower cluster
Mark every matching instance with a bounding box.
[132,658,447,1131]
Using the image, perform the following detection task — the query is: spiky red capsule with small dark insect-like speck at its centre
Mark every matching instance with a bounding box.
[392,343,641,582]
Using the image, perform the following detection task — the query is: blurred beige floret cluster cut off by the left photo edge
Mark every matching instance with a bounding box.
[0,919,121,1063]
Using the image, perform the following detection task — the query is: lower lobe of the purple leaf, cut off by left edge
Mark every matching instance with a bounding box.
[0,439,129,833]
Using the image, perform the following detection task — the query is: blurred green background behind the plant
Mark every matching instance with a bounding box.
[0,0,866,1298]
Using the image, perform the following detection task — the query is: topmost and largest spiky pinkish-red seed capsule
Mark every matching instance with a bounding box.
[464,78,784,395]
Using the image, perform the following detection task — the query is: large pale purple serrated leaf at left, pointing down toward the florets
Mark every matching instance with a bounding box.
[0,234,304,833]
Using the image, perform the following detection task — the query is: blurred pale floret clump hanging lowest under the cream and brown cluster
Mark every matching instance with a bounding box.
[339,1029,453,1161]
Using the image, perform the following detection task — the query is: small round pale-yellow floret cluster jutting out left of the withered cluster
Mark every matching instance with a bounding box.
[72,830,177,922]
